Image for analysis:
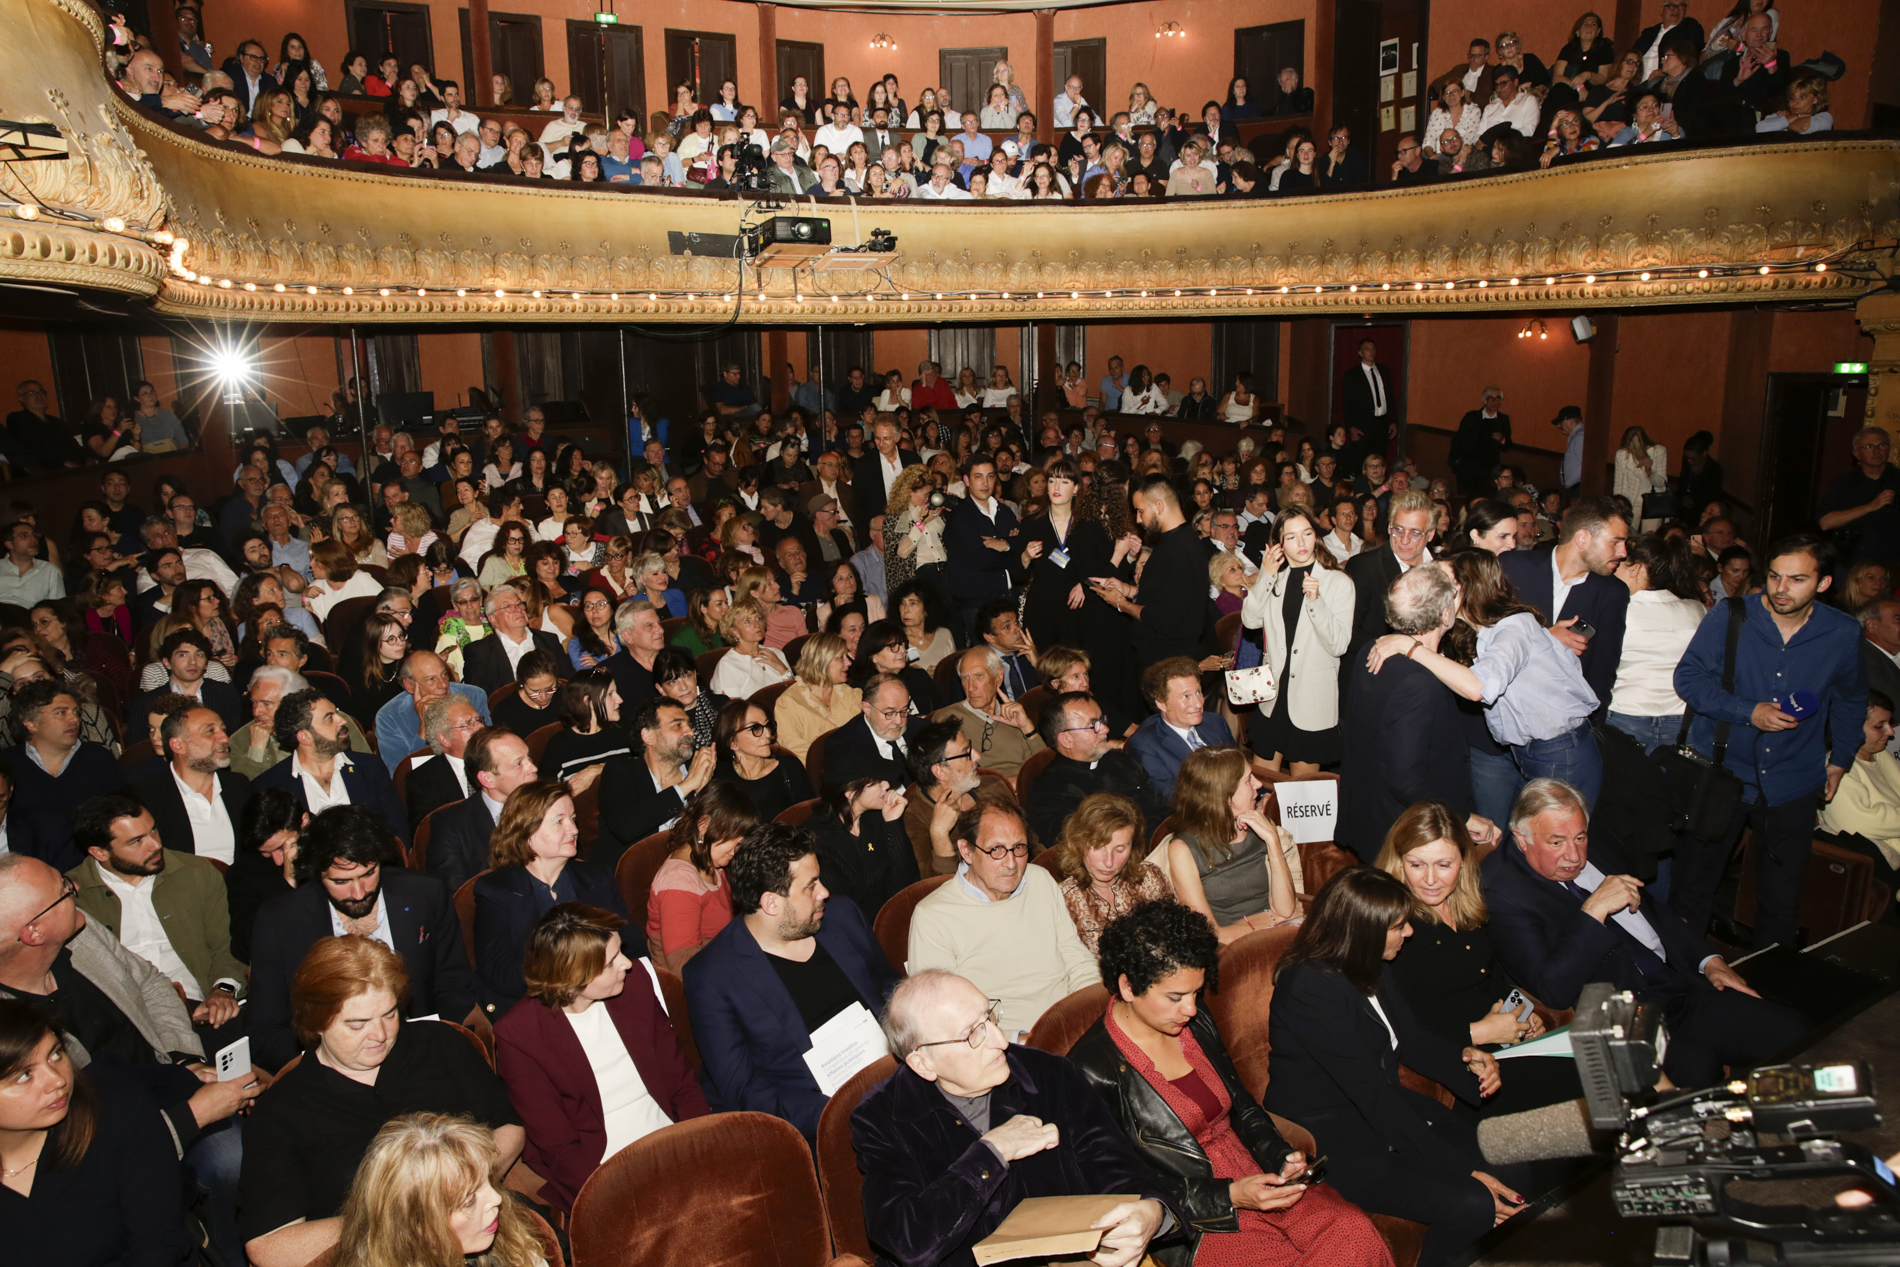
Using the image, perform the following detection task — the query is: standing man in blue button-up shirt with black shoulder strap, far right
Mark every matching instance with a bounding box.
[1670,534,1868,946]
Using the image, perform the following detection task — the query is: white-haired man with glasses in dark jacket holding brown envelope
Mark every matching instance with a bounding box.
[851,964,1174,1267]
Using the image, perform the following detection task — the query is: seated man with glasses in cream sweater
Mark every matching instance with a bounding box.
[904,798,1100,1043]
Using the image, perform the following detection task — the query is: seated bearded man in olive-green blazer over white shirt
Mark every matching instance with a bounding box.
[67,792,247,1028]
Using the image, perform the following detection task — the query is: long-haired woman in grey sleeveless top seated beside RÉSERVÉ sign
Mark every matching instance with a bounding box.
[1165,745,1300,942]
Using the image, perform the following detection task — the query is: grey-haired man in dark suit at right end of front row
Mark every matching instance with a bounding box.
[1484,779,1807,1090]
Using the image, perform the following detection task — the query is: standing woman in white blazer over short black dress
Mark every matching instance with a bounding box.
[1241,509,1353,775]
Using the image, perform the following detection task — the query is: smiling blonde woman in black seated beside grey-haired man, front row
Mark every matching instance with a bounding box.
[1378,802,1583,1121]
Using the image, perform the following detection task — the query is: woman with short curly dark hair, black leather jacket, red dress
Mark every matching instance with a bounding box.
[1070,902,1393,1267]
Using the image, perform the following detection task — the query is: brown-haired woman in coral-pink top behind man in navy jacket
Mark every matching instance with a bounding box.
[646,783,758,973]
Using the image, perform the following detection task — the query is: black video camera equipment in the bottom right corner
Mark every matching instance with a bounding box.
[1571,982,1900,1265]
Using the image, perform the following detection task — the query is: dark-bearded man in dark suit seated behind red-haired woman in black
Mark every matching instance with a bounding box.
[251,801,475,1069]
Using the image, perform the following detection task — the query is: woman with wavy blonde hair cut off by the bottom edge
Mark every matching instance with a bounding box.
[331,1113,547,1267]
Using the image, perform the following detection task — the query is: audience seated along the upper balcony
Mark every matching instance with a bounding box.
[103,0,1845,208]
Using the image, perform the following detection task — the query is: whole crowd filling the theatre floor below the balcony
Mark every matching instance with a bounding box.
[0,322,1900,1267]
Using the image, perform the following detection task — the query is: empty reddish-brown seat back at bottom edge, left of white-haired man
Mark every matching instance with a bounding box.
[568,1113,830,1267]
